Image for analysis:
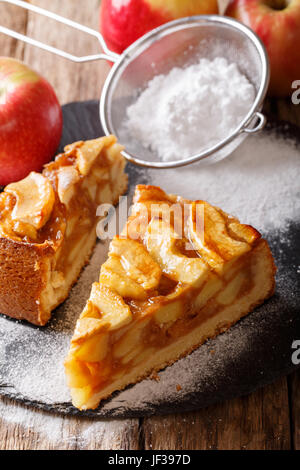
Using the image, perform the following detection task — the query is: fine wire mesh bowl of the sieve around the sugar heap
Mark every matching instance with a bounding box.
[101,16,268,167]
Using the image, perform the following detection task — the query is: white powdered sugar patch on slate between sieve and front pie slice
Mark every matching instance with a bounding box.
[152,132,300,233]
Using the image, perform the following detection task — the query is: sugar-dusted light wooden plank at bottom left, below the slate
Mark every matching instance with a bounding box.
[0,398,139,450]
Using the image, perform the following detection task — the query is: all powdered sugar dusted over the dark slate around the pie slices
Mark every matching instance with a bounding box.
[0,121,300,422]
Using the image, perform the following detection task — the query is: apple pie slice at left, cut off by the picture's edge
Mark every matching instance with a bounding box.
[0,136,127,325]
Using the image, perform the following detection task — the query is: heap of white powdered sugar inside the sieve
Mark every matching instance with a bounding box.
[123,57,255,161]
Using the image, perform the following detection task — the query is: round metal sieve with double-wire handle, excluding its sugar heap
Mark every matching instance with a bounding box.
[0,0,269,168]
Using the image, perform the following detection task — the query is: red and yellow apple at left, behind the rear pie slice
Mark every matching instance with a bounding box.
[0,57,62,186]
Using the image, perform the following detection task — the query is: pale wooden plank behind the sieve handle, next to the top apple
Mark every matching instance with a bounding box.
[24,0,110,104]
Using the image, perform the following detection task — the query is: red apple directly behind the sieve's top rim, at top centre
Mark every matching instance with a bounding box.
[100,0,218,54]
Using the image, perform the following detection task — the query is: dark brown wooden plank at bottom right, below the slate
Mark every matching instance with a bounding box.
[143,378,290,450]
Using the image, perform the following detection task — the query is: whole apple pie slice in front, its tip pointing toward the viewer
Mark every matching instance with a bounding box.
[65,186,275,410]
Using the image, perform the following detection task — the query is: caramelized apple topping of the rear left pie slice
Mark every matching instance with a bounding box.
[0,136,126,243]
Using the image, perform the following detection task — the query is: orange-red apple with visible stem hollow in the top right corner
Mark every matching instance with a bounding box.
[226,0,300,96]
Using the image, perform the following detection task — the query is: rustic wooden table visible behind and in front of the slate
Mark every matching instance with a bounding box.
[0,0,300,450]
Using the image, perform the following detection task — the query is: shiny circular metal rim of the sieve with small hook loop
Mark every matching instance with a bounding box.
[99,15,270,169]
